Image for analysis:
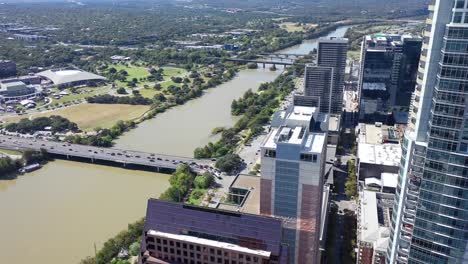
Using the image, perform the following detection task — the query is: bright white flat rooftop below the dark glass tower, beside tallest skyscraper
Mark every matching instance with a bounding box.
[358,143,401,166]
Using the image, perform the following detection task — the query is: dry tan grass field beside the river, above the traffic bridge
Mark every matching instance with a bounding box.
[5,104,150,131]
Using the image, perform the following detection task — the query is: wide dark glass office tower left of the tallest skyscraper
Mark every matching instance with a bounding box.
[359,34,422,123]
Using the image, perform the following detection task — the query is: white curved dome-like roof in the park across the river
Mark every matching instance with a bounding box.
[37,68,106,85]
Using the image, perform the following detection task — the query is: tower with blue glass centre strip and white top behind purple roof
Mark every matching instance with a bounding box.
[260,106,328,264]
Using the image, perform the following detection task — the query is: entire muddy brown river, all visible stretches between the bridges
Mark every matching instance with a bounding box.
[0,27,347,264]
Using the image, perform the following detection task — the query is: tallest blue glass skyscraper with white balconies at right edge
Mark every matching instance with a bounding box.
[387,0,468,264]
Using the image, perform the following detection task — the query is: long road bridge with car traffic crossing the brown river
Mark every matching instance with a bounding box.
[0,135,213,173]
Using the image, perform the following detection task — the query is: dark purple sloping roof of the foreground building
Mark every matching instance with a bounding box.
[144,199,282,256]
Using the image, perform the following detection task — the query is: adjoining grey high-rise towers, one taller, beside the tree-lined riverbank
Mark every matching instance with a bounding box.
[304,38,348,114]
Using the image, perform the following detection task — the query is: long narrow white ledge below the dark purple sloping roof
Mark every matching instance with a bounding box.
[147,230,271,258]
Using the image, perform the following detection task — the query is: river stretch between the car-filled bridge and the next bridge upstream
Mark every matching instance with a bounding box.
[116,68,280,157]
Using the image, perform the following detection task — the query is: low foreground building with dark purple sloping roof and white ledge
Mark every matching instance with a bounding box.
[139,199,288,264]
